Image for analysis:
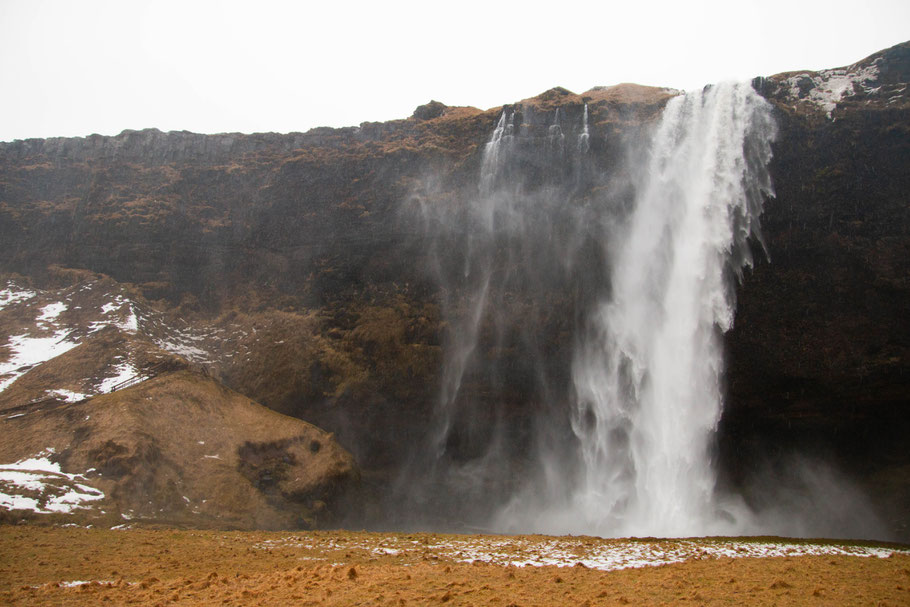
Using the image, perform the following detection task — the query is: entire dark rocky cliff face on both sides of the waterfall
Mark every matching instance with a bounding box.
[0,44,910,536]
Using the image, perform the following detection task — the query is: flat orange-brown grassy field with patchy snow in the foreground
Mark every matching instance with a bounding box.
[0,525,910,607]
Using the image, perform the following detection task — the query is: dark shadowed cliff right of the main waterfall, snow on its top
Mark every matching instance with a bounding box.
[721,44,910,534]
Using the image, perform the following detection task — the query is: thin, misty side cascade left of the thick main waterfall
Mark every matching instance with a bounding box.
[406,106,602,525]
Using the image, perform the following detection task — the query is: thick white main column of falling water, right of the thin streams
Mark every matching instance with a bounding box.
[566,84,775,536]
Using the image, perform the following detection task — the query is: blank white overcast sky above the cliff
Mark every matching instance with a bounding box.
[0,0,910,141]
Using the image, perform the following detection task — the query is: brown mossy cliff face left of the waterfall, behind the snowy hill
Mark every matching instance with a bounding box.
[0,85,670,462]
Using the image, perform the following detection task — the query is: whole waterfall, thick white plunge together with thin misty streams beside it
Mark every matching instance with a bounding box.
[406,84,775,536]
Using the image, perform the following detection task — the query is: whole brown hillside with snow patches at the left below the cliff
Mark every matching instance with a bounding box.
[0,277,357,528]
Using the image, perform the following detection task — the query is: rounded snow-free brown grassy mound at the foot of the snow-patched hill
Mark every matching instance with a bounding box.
[0,370,356,528]
